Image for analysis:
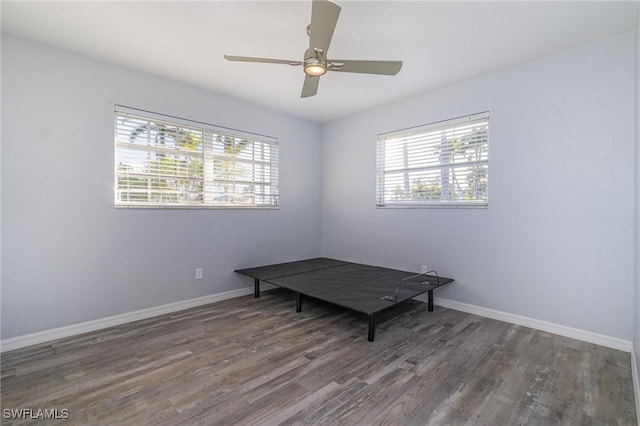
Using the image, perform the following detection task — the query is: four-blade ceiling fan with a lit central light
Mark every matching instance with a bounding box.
[224,0,402,98]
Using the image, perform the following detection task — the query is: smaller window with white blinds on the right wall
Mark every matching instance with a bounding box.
[376,112,489,207]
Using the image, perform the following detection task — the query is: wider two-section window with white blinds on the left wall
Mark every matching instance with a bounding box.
[115,107,279,208]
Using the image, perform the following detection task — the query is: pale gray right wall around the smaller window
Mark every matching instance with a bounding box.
[322,33,634,340]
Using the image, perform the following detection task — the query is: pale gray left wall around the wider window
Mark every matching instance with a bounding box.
[1,34,321,339]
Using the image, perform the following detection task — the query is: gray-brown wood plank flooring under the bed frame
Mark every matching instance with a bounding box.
[1,290,637,426]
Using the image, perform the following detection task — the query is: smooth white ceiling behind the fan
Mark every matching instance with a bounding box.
[1,0,639,122]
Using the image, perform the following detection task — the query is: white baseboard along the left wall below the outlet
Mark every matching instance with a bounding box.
[0,287,253,352]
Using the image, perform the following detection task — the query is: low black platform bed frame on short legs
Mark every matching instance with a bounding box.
[235,257,453,342]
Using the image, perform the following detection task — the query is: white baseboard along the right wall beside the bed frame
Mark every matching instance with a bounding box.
[416,294,633,352]
